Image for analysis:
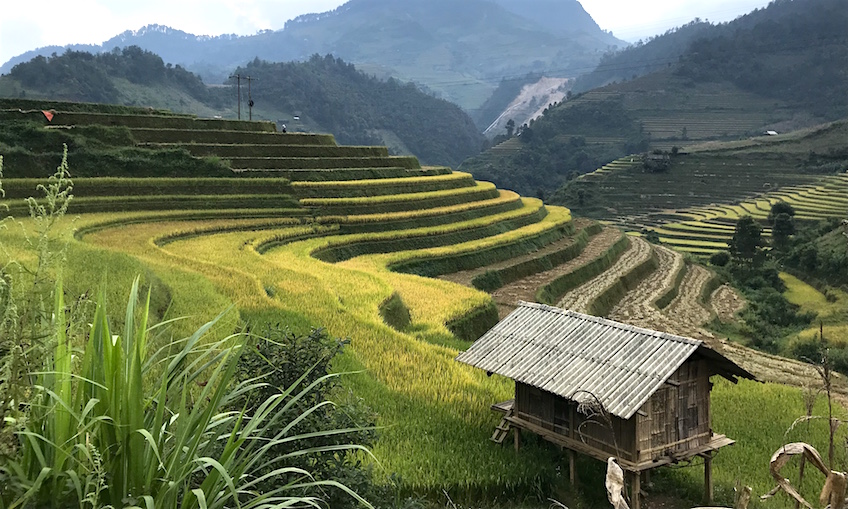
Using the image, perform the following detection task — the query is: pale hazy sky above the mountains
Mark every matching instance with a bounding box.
[0,0,769,63]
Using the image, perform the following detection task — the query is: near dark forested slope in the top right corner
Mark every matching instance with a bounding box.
[678,0,848,120]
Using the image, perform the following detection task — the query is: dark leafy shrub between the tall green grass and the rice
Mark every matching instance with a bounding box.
[231,325,377,509]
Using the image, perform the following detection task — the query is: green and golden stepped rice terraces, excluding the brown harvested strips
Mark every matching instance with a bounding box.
[4,103,574,491]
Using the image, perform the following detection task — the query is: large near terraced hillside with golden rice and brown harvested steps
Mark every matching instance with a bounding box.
[6,102,848,505]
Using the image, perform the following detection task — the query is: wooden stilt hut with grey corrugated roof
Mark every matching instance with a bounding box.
[457,302,754,509]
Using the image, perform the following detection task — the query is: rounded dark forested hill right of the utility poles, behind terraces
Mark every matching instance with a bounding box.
[237,55,484,166]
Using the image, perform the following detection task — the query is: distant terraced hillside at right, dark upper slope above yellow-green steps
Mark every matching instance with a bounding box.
[554,121,848,254]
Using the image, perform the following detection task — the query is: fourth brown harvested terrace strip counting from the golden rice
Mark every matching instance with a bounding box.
[609,246,684,330]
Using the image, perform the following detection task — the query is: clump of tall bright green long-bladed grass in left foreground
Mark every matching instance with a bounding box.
[0,281,370,509]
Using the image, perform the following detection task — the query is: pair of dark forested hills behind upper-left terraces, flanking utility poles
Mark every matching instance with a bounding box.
[0,46,484,166]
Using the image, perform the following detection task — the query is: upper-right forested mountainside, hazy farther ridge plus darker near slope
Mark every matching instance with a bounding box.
[574,0,848,120]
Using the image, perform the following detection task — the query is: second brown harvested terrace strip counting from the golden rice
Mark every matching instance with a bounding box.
[492,228,622,318]
